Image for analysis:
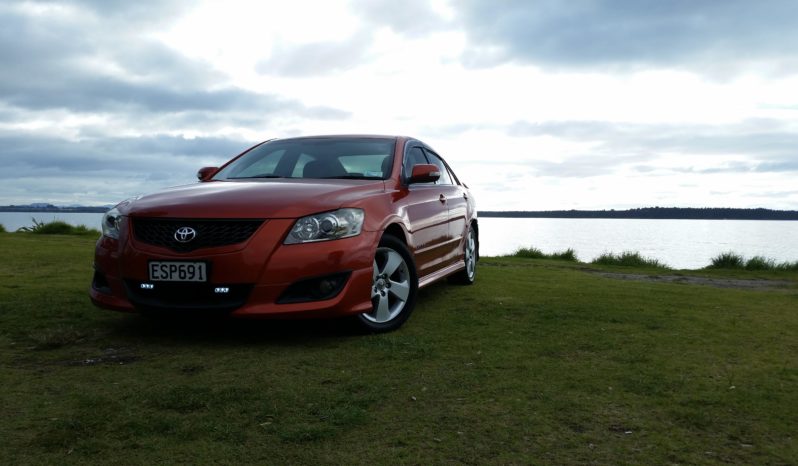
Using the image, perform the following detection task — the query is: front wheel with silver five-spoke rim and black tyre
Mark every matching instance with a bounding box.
[355,235,418,333]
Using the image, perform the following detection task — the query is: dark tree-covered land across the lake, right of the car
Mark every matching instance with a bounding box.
[479,207,798,220]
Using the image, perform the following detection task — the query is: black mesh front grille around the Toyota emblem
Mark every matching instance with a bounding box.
[132,217,263,252]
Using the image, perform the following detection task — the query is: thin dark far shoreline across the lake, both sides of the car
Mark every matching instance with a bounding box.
[0,206,798,220]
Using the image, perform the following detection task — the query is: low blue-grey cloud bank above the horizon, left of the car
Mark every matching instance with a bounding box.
[0,133,254,204]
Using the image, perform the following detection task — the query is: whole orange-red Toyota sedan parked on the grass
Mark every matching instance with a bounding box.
[90,136,479,332]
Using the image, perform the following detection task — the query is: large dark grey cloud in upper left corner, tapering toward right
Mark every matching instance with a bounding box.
[0,1,347,118]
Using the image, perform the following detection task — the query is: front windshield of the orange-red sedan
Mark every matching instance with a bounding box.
[213,138,395,180]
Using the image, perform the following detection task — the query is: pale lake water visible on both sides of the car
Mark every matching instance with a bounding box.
[0,212,798,269]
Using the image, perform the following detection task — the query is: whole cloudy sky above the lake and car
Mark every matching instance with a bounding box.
[0,0,798,210]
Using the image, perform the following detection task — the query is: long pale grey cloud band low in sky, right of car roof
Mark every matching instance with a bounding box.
[429,119,798,178]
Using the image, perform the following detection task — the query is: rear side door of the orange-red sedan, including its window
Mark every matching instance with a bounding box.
[425,149,468,263]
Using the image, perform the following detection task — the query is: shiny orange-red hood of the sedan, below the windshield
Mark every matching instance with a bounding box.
[119,179,385,218]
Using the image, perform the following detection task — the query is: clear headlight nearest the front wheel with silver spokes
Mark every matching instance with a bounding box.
[284,209,365,244]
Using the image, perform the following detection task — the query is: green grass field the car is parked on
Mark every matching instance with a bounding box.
[0,233,798,465]
